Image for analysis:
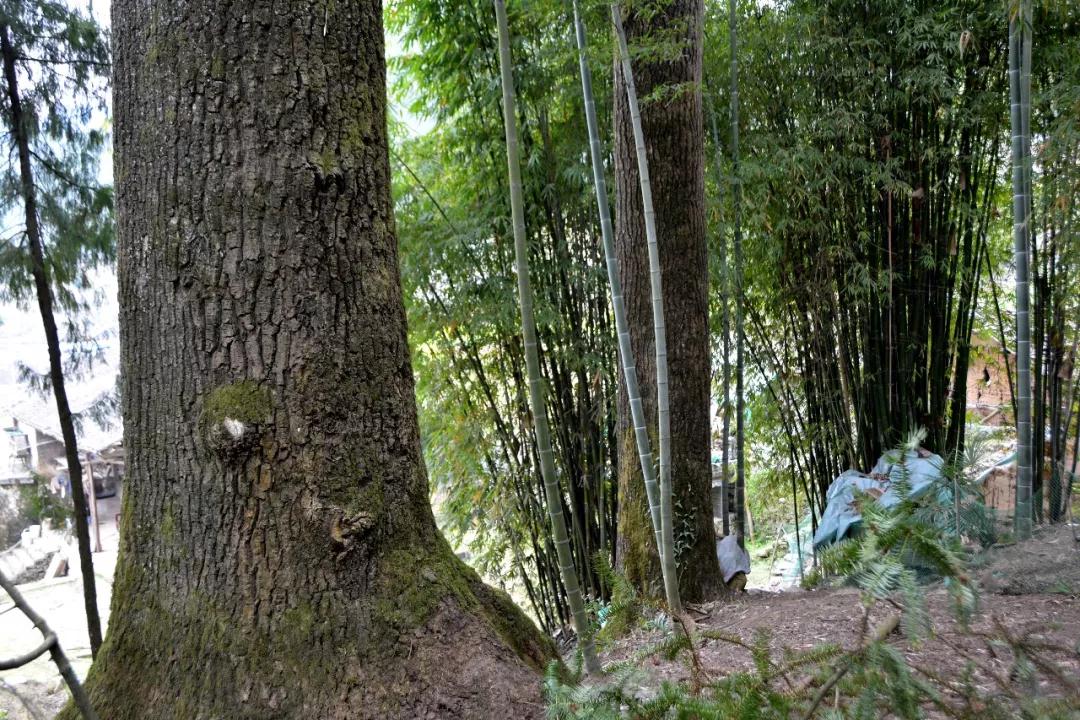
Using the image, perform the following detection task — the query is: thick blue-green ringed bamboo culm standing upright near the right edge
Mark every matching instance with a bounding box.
[1009,0,1031,540]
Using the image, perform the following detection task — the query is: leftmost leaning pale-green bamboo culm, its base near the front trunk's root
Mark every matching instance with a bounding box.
[495,0,600,673]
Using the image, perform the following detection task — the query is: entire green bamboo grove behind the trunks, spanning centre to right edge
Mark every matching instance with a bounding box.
[386,0,1080,630]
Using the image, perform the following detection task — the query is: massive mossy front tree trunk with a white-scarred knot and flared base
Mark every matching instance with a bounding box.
[65,0,550,720]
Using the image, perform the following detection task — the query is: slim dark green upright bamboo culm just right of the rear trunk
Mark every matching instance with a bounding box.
[728,0,746,545]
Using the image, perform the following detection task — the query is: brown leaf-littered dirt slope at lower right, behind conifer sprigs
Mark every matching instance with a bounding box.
[604,526,1080,718]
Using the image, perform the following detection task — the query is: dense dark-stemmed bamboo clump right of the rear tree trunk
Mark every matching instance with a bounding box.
[704,0,1049,522]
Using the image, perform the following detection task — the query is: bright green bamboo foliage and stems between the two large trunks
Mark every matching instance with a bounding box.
[386,0,619,631]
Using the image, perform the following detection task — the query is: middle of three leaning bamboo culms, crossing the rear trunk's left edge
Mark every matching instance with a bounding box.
[573,0,663,553]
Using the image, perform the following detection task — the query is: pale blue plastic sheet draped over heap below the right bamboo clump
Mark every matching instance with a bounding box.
[813,448,945,549]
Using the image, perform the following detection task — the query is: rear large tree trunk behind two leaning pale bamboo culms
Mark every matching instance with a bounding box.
[615,0,721,601]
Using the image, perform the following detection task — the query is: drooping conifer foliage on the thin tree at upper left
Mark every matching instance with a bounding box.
[0,0,113,310]
